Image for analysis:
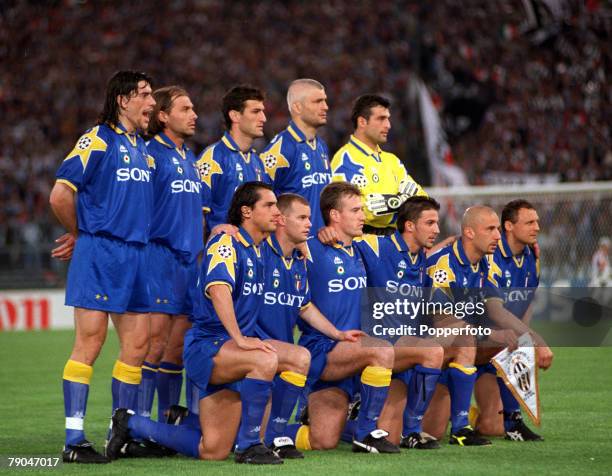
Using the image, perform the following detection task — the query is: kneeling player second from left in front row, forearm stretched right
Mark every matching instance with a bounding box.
[256,193,362,458]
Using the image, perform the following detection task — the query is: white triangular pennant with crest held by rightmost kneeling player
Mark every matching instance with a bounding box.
[491,333,540,426]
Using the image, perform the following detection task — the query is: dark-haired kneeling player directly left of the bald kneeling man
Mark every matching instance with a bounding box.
[354,197,444,449]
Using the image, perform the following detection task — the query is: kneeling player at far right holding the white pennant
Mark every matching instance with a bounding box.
[475,200,553,441]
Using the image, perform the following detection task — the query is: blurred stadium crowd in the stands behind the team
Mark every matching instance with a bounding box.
[0,0,612,276]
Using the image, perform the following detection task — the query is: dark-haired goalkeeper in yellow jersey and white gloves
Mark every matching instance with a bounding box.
[331,94,427,235]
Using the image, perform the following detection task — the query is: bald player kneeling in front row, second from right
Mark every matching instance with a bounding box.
[423,206,500,446]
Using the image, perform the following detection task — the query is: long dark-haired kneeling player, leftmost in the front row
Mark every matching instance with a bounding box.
[107,182,296,464]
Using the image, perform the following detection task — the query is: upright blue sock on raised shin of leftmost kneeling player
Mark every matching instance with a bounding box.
[236,377,272,452]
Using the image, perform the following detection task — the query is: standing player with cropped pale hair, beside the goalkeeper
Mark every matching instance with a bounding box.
[260,79,331,232]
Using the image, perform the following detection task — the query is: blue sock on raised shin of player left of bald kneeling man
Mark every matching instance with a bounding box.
[402,365,442,436]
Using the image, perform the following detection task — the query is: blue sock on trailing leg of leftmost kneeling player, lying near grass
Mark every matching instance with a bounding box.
[128,415,202,458]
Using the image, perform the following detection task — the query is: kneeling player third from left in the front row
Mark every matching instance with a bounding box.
[288,182,399,453]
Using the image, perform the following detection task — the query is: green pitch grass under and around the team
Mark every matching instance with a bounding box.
[0,331,612,476]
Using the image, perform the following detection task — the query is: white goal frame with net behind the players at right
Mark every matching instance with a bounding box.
[427,181,612,287]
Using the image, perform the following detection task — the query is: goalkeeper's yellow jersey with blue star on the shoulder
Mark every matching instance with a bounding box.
[331,135,427,228]
